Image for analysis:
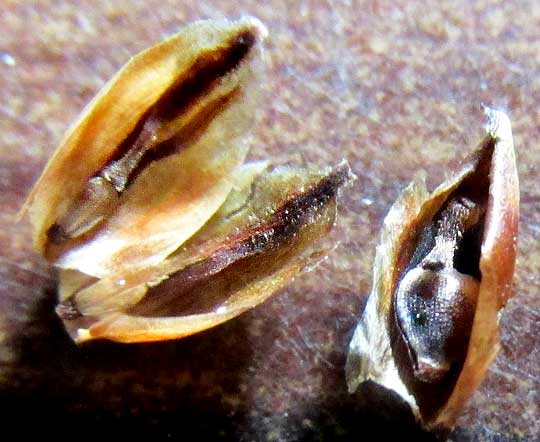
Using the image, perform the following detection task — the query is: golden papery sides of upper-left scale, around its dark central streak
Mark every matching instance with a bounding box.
[23,18,266,277]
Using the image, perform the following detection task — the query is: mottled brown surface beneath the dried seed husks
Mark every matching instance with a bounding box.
[0,0,540,441]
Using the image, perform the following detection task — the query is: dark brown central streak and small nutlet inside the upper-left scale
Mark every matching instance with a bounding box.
[48,32,256,244]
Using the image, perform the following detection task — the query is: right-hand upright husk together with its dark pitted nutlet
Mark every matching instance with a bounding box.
[346,108,519,430]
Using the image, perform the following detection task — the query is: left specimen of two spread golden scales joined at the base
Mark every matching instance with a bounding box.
[21,18,352,342]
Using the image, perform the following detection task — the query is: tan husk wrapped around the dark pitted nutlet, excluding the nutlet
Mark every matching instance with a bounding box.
[346,109,519,431]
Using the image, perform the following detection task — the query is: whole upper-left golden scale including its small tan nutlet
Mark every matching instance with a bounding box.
[25,18,266,277]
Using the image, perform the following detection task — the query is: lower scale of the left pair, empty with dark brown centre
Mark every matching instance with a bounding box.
[56,164,352,342]
